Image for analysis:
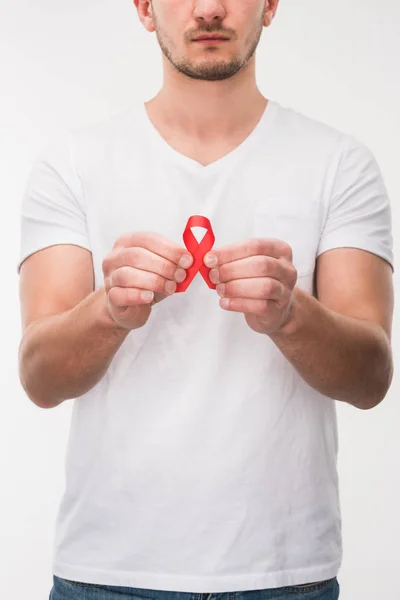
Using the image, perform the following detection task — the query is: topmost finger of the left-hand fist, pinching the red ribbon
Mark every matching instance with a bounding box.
[113,231,193,269]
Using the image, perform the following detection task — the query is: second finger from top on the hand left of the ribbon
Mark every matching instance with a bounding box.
[103,247,186,282]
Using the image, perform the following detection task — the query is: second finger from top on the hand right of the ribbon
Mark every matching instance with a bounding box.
[210,256,295,285]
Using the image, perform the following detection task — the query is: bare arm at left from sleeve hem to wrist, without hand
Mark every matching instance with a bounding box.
[19,245,129,408]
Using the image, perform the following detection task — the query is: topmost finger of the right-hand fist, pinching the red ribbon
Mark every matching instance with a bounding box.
[204,238,293,267]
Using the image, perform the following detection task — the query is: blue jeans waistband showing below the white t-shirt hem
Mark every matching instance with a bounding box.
[49,575,339,600]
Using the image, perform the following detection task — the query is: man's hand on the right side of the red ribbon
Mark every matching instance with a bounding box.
[204,239,297,334]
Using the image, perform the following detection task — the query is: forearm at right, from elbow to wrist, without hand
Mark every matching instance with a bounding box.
[270,288,393,409]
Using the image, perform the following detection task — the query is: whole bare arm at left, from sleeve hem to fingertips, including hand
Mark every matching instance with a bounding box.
[19,232,193,408]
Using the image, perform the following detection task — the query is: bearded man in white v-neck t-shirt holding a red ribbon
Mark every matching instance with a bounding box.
[19,0,393,600]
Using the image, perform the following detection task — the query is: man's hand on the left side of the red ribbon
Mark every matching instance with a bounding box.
[102,232,193,329]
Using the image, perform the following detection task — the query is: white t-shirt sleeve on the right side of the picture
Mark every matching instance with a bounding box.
[317,136,394,271]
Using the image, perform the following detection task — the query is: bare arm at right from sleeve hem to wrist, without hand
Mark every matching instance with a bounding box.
[271,248,394,409]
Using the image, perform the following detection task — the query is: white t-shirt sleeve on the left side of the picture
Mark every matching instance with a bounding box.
[17,131,91,274]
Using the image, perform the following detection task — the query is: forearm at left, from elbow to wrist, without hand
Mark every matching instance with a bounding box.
[19,287,130,408]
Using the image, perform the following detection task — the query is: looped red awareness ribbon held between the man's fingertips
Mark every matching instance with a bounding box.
[175,215,217,293]
